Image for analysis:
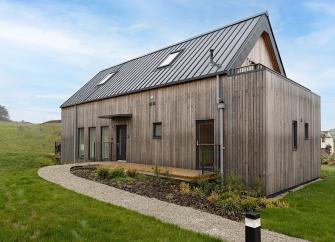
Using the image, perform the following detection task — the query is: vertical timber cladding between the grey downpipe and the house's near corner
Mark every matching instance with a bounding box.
[223,70,266,186]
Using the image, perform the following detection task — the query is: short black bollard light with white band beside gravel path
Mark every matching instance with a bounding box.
[245,212,261,242]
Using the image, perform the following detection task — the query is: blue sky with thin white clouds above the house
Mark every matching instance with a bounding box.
[0,0,335,129]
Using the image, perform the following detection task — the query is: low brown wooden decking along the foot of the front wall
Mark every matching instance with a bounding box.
[99,161,215,181]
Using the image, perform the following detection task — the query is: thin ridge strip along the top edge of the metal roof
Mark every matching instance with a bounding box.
[99,11,269,73]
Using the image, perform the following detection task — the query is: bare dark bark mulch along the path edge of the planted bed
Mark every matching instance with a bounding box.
[71,166,242,221]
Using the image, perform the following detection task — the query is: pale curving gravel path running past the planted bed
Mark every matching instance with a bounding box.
[38,162,310,241]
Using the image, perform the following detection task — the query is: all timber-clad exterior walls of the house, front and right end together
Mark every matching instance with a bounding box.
[62,67,320,195]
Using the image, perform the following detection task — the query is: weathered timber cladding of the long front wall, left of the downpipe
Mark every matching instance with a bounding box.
[62,77,218,169]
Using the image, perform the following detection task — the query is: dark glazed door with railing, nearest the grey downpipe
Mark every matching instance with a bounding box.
[197,120,215,171]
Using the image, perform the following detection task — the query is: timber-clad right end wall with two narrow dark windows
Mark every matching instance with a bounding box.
[265,68,321,194]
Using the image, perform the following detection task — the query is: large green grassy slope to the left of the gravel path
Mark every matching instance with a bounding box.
[0,122,217,241]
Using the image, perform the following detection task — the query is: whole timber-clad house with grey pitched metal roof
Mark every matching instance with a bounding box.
[61,13,320,195]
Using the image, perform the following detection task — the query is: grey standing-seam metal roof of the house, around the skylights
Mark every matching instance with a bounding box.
[61,13,285,107]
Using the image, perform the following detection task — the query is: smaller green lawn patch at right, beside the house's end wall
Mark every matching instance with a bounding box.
[262,166,335,241]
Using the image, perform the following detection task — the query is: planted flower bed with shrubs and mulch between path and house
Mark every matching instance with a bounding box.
[71,166,287,221]
